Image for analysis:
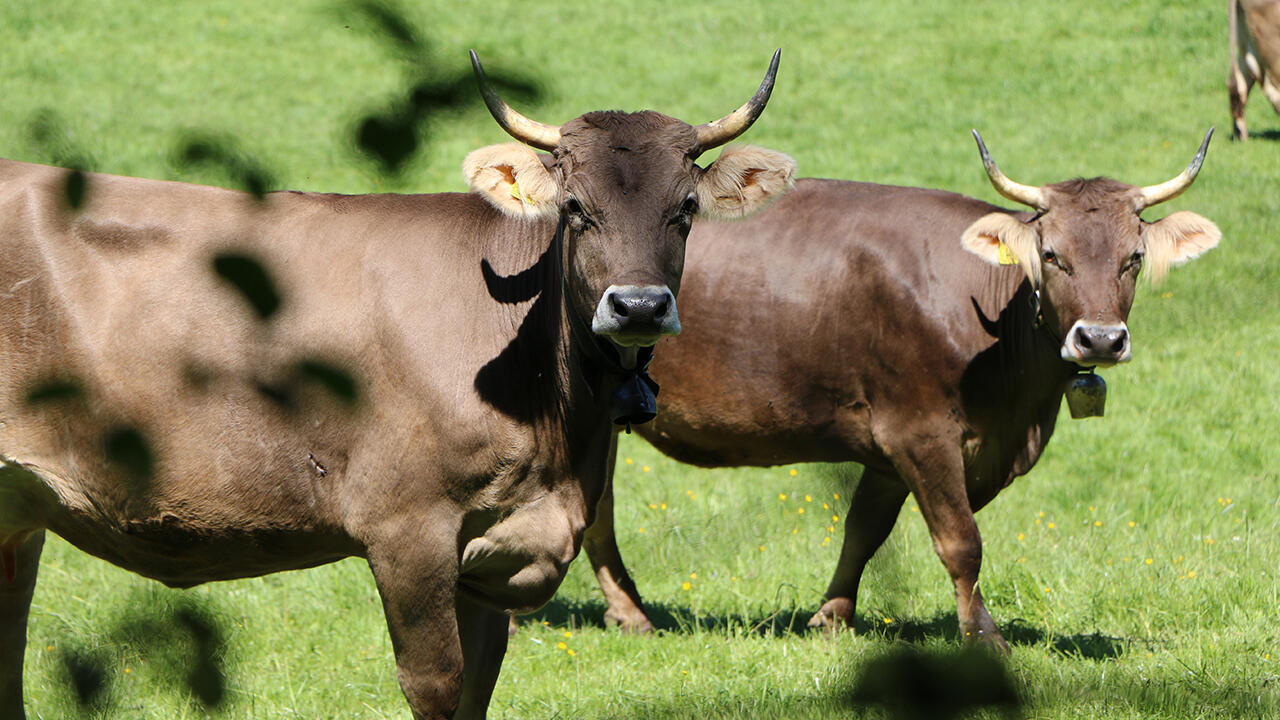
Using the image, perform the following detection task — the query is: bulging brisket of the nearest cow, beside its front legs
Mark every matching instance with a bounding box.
[458,495,586,612]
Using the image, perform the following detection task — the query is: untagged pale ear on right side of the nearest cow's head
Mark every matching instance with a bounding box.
[698,145,796,215]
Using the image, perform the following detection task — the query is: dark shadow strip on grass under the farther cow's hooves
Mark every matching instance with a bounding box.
[518,597,1129,660]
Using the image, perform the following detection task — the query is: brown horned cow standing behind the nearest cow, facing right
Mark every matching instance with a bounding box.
[586,131,1220,650]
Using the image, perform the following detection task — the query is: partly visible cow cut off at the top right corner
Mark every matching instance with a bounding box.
[1226,0,1280,140]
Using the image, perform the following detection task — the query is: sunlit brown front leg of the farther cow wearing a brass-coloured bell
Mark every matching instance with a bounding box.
[892,433,1009,653]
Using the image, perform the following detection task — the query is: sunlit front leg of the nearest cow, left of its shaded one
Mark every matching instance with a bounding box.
[369,534,468,720]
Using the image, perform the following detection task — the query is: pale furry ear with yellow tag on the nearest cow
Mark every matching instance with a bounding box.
[462,142,559,218]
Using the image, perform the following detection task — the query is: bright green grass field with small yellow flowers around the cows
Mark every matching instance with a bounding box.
[0,0,1280,720]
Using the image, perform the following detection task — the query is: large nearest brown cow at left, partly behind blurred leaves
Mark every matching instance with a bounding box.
[0,54,794,719]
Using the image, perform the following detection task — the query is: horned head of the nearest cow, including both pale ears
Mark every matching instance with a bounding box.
[463,51,795,355]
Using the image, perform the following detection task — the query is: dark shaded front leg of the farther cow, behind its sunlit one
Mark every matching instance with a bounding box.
[809,468,908,630]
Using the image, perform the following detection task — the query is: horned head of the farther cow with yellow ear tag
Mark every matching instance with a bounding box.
[963,128,1222,366]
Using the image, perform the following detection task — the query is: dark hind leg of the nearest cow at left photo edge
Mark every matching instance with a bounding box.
[0,530,45,720]
